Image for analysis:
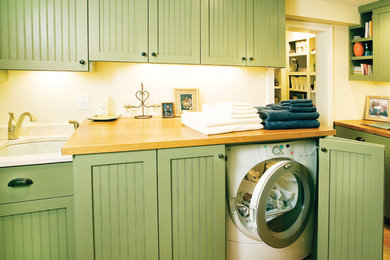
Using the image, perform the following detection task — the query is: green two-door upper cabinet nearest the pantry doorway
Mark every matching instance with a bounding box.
[201,0,285,67]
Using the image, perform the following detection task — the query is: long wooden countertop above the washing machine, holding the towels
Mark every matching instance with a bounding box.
[62,117,336,155]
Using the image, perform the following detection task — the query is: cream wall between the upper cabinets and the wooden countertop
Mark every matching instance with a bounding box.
[0,62,273,125]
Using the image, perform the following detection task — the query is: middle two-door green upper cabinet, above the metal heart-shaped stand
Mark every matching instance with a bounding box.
[89,0,200,64]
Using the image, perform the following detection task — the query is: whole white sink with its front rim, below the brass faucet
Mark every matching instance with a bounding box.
[0,138,72,167]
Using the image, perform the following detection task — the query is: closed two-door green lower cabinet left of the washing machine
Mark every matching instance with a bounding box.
[74,145,225,260]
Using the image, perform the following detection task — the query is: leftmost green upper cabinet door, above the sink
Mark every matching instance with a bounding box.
[0,0,88,71]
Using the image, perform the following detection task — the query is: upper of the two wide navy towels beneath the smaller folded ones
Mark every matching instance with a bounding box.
[258,109,320,121]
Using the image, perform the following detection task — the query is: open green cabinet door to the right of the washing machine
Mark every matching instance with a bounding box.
[318,137,384,260]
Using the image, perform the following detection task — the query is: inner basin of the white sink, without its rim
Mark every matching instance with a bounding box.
[0,140,65,156]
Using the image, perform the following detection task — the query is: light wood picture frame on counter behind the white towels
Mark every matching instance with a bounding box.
[173,88,199,116]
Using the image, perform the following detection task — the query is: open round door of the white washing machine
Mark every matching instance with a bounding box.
[250,160,315,248]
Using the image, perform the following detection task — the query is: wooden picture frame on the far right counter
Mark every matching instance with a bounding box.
[364,96,390,122]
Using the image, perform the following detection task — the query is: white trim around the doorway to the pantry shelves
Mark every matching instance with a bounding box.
[286,20,334,127]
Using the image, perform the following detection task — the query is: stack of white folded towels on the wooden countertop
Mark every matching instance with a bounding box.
[181,102,263,135]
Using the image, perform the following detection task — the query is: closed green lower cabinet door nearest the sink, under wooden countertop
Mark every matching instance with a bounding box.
[73,150,158,260]
